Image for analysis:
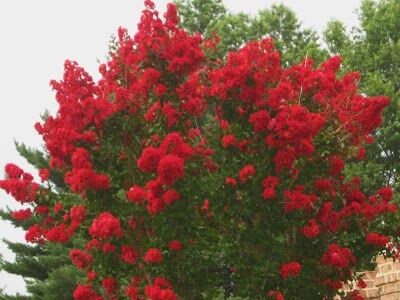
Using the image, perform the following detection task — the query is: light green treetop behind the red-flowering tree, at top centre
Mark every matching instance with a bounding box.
[175,0,327,65]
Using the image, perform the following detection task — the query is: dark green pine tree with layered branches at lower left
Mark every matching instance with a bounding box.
[0,143,83,300]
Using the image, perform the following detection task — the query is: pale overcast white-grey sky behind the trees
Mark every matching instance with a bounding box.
[0,0,361,294]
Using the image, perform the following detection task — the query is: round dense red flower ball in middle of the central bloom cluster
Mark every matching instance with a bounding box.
[157,154,185,185]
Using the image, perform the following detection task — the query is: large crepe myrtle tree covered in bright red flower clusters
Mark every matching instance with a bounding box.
[0,0,397,300]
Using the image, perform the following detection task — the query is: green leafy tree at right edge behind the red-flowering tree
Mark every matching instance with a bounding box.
[324,0,400,191]
